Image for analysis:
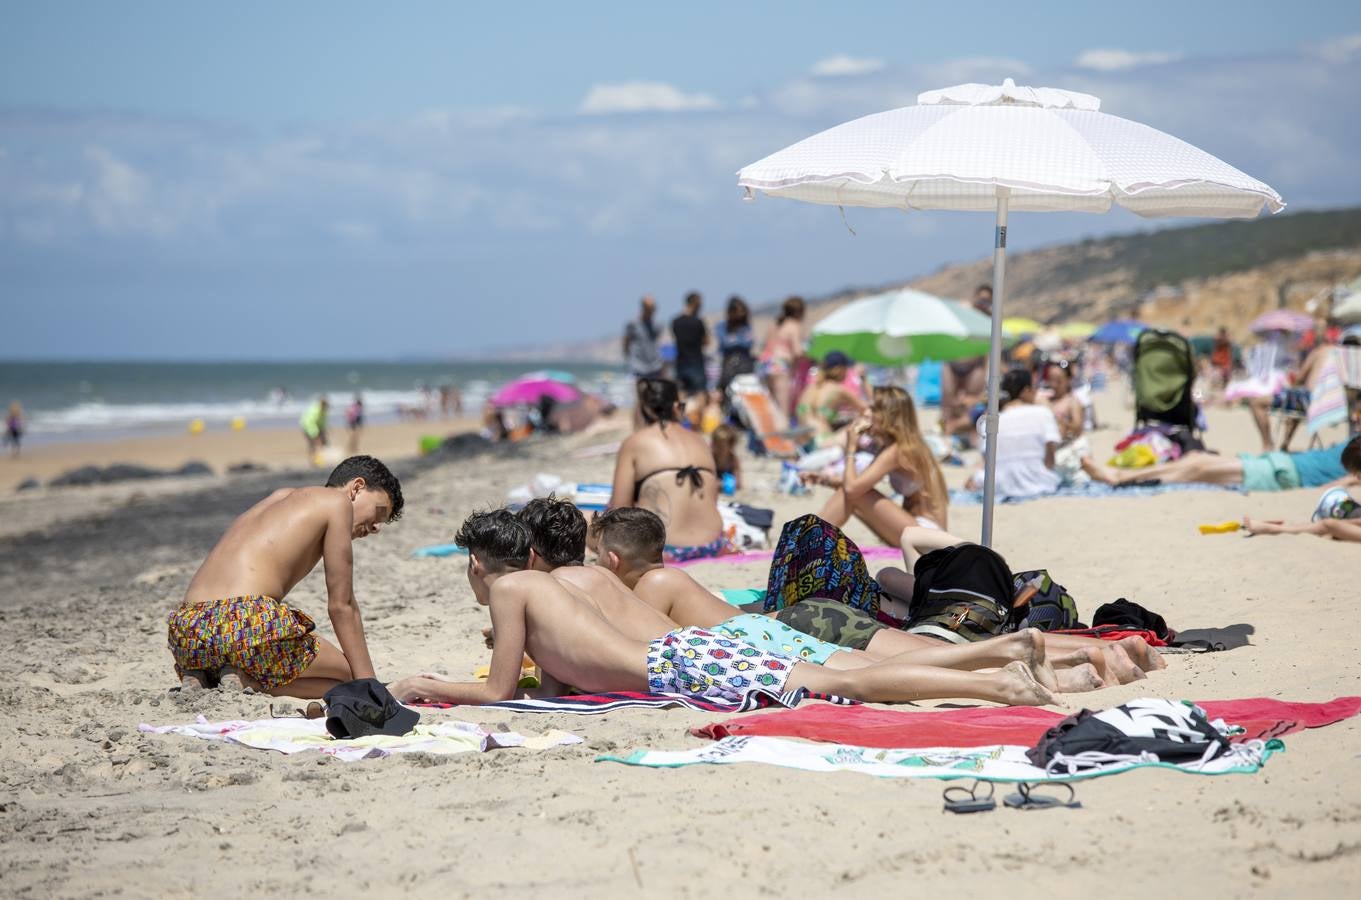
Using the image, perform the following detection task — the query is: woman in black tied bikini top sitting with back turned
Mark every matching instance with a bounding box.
[610,379,736,562]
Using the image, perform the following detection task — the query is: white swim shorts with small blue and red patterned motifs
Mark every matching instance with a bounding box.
[648,628,799,703]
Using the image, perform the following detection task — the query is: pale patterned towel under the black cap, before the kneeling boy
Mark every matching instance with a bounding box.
[137,716,581,762]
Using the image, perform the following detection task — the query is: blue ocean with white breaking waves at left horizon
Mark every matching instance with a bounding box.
[0,362,633,444]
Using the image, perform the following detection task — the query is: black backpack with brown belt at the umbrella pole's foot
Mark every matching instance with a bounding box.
[904,543,1014,644]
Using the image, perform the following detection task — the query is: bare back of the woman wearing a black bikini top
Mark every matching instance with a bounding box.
[610,422,723,546]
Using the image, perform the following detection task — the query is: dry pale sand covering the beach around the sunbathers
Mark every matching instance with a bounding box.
[0,396,1361,900]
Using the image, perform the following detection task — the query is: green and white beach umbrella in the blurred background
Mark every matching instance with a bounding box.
[810,289,992,366]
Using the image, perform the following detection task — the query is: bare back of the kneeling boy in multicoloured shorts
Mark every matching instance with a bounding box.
[184,487,348,603]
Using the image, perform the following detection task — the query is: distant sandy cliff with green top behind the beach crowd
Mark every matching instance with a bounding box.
[501,208,1361,362]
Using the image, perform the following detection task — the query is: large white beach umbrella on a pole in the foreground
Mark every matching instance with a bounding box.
[738,79,1285,545]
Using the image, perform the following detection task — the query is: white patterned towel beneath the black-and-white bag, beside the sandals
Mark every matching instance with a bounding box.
[596,737,1285,782]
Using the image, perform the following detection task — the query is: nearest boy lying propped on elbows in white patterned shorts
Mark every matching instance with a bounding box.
[392,509,1056,705]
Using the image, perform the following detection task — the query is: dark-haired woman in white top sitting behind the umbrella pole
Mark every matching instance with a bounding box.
[973,369,1063,497]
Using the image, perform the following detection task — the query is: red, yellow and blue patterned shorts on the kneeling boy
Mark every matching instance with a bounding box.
[169,595,317,690]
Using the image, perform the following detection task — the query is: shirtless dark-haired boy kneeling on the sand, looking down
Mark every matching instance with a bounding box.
[169,456,403,700]
